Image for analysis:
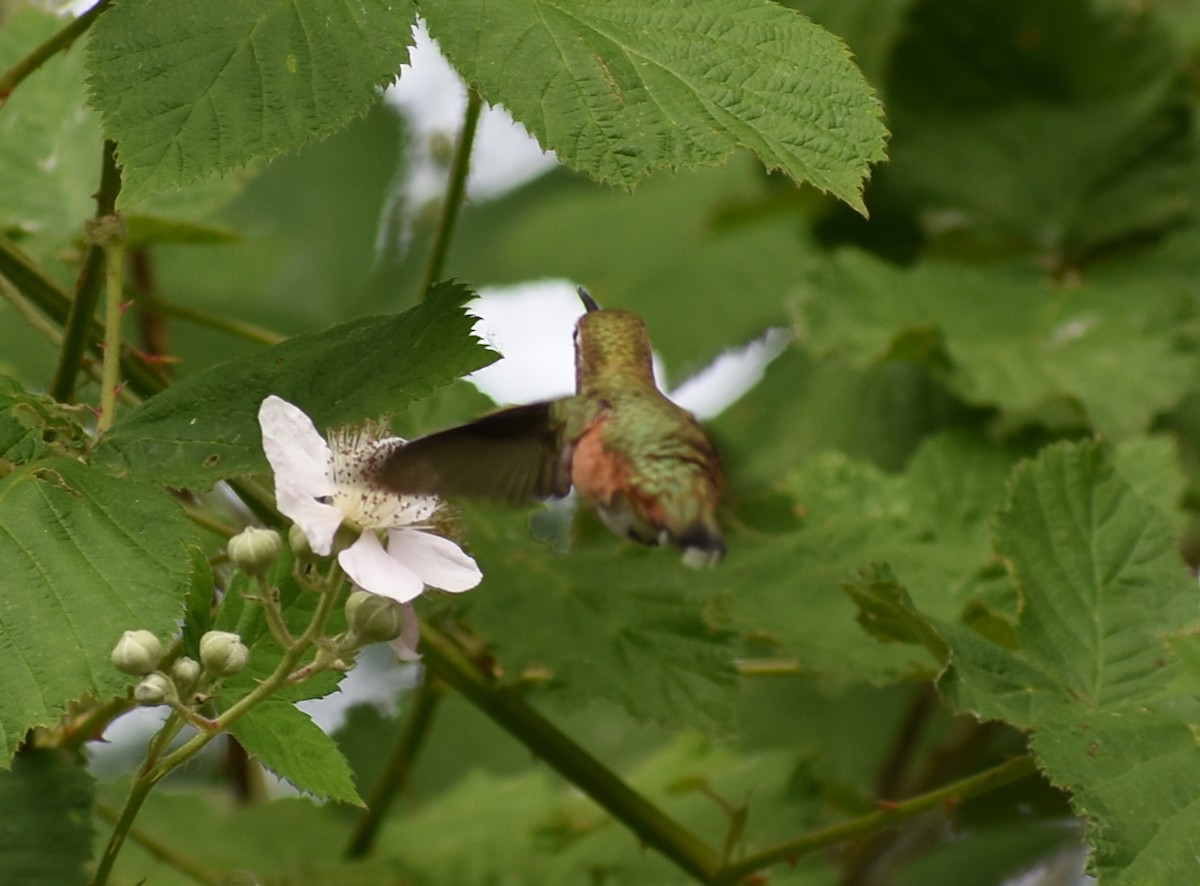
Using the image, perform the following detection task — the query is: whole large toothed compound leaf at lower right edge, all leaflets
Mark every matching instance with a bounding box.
[941,444,1200,884]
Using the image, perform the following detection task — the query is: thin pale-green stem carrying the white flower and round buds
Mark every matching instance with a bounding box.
[92,570,338,886]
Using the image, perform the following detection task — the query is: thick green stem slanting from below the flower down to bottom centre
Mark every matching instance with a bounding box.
[421,625,720,882]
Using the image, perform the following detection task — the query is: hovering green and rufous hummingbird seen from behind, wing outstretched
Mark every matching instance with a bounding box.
[378,287,725,567]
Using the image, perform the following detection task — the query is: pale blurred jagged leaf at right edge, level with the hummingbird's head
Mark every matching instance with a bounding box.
[803,251,1200,438]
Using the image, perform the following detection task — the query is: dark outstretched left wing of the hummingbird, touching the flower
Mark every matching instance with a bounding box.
[377,401,571,502]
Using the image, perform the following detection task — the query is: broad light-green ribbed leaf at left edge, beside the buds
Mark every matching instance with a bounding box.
[0,460,192,764]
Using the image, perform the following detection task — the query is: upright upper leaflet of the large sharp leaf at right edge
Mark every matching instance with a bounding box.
[996,444,1195,707]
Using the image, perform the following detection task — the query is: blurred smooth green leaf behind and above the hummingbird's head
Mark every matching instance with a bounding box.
[448,154,806,372]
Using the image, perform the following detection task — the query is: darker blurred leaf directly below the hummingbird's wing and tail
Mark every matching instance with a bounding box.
[461,499,737,729]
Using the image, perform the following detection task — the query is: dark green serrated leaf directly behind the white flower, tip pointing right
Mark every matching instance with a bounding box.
[87,283,494,489]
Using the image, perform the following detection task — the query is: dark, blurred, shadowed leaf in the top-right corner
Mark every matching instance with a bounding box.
[887,0,1196,256]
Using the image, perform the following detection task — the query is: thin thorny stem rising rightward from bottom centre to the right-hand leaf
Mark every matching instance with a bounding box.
[710,756,1037,886]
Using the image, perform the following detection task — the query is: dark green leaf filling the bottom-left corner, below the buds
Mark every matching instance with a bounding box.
[0,749,94,886]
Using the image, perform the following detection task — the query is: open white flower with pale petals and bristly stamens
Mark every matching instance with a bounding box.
[258,394,484,603]
